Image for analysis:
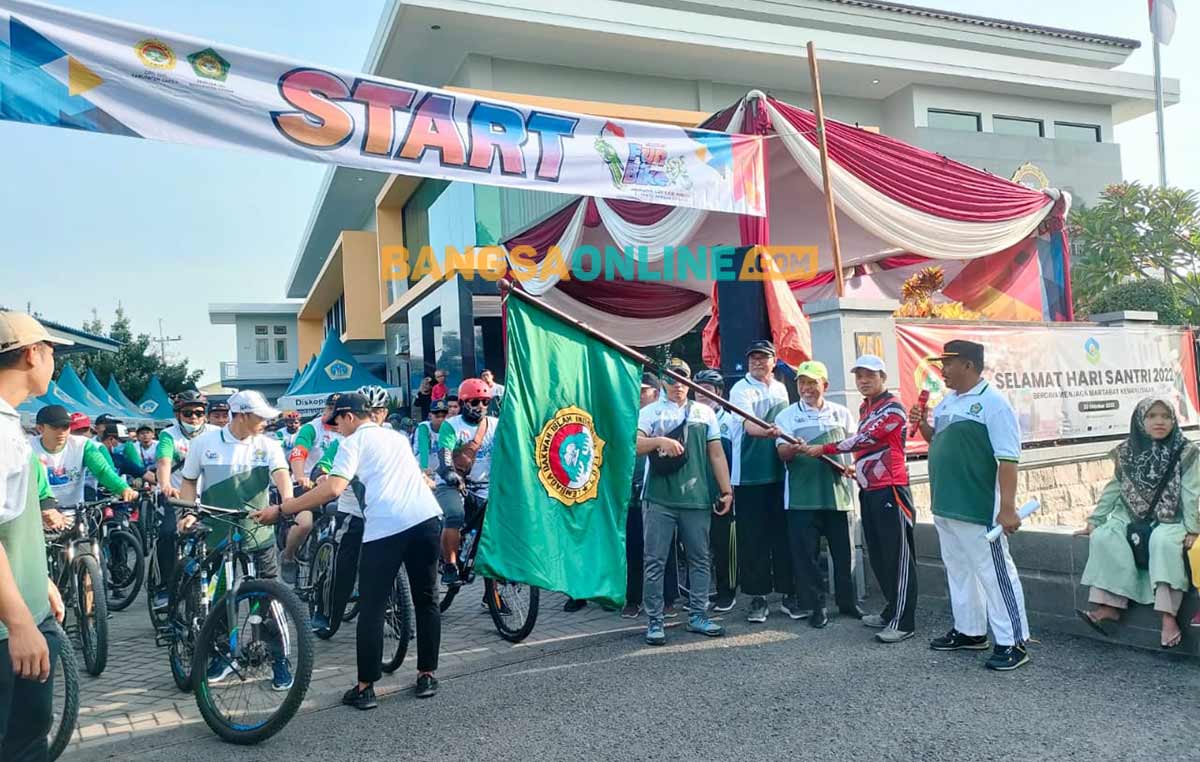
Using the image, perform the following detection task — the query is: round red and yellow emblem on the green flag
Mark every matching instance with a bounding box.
[534,406,605,505]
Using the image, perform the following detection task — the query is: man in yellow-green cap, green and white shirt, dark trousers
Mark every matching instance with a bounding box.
[775,360,862,628]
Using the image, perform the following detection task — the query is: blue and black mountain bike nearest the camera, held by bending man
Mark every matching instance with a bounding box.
[166,500,313,744]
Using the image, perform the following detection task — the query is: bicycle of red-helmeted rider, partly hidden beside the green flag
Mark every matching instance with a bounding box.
[438,484,541,643]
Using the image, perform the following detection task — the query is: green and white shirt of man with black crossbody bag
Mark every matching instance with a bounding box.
[637,400,721,510]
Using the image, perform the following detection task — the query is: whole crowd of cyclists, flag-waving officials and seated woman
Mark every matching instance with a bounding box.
[0,313,1200,758]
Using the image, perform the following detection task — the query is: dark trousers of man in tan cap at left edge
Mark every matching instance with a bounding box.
[0,619,59,762]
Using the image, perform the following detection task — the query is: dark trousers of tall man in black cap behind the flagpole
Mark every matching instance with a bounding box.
[733,481,794,596]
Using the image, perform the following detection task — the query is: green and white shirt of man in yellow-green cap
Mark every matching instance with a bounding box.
[775,400,854,511]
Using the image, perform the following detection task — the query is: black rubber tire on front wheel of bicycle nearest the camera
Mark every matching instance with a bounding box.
[192,580,313,745]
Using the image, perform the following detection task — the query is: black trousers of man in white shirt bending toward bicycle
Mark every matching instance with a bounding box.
[356,517,442,683]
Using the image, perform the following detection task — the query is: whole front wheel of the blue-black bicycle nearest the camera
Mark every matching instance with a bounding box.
[192,580,313,744]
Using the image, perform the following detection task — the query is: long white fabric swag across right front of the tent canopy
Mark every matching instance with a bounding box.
[766,102,1054,259]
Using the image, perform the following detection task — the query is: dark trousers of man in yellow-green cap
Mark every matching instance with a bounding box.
[787,510,858,611]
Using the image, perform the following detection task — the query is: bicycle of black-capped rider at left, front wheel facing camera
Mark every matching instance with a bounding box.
[46,498,113,676]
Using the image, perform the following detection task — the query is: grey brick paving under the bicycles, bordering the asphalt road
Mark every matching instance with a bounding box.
[64,580,643,760]
